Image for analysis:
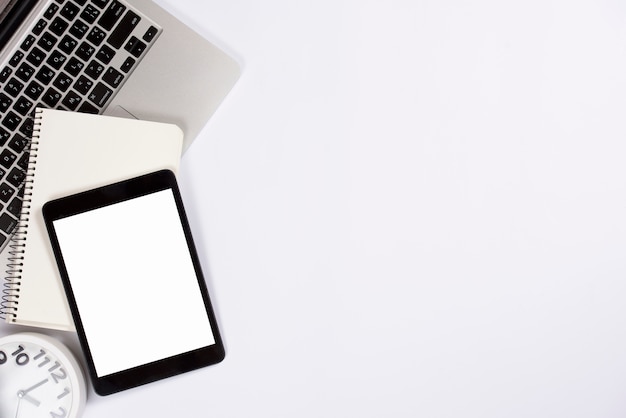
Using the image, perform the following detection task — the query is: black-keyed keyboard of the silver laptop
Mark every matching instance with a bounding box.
[0,0,161,250]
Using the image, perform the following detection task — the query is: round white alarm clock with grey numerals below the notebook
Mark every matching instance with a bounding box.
[0,332,87,418]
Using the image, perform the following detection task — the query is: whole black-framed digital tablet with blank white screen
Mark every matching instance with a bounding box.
[43,170,224,395]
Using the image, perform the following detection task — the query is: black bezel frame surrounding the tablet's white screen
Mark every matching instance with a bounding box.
[43,170,225,395]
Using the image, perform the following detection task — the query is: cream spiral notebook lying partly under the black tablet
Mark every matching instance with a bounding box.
[2,109,183,331]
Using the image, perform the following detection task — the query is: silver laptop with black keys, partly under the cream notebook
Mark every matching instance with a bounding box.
[0,0,240,250]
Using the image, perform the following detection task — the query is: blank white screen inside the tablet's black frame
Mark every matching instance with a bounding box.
[54,189,215,377]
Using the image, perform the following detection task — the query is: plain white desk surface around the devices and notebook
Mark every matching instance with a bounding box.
[0,0,626,418]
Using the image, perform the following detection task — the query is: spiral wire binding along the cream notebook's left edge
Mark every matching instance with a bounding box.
[0,109,41,322]
